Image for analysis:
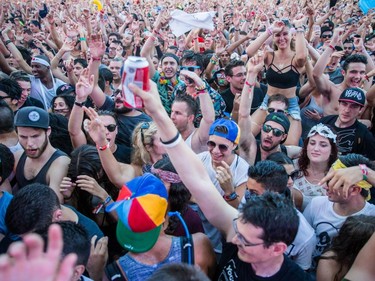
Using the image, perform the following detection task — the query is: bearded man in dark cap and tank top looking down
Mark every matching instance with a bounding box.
[14,106,70,202]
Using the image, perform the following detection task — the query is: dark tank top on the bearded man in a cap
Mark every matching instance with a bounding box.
[16,149,67,189]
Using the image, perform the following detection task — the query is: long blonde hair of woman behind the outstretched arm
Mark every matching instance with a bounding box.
[132,122,157,166]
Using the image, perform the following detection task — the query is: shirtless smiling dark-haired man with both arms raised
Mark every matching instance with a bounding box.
[313,28,375,116]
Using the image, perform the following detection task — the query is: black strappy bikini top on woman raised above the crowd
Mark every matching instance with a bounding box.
[266,53,300,89]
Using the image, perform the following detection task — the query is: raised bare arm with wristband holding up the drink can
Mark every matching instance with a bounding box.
[130,81,238,241]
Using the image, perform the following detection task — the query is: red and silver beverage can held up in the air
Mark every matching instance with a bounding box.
[121,56,150,108]
